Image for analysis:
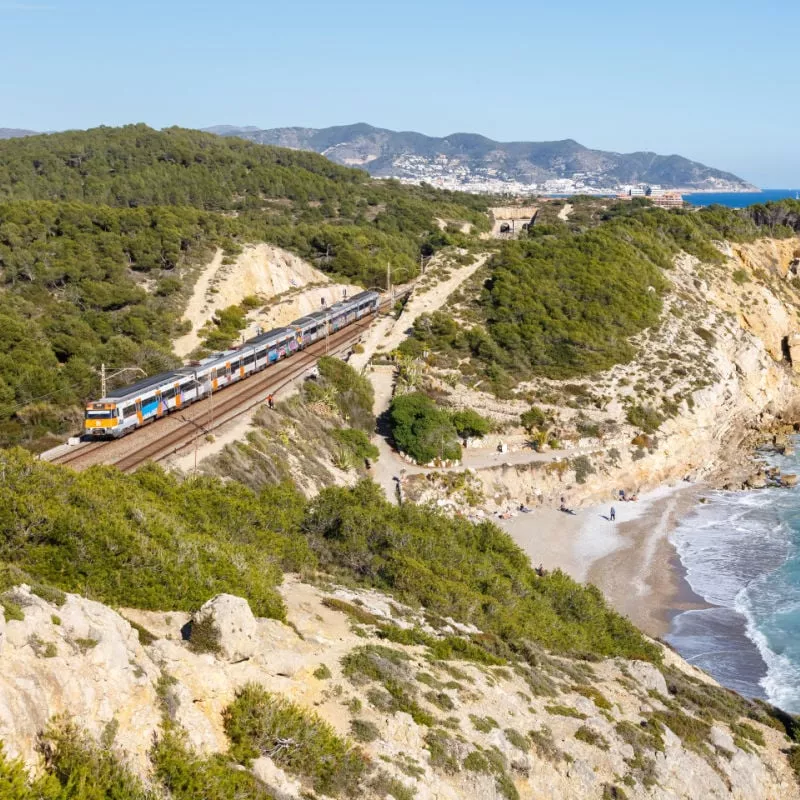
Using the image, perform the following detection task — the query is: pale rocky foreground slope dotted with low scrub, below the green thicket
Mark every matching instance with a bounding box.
[0,579,800,800]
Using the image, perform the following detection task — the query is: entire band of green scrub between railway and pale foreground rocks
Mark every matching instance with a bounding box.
[0,450,658,659]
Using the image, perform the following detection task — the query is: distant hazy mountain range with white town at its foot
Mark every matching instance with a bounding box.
[206,122,756,191]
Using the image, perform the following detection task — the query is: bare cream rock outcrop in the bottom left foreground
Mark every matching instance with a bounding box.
[0,586,161,768]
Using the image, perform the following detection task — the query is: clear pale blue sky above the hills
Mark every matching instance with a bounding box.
[0,0,800,188]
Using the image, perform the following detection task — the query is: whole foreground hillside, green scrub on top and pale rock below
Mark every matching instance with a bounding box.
[0,451,800,800]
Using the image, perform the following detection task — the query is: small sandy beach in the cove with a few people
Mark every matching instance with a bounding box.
[499,483,707,636]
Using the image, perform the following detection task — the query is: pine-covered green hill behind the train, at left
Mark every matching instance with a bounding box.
[0,125,488,445]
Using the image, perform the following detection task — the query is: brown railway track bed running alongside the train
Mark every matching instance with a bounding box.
[51,301,389,472]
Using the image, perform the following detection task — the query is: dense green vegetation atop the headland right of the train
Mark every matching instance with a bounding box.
[401,199,800,391]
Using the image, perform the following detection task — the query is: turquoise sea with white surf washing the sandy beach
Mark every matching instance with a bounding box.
[667,444,800,713]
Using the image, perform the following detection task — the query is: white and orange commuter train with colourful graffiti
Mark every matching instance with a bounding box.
[84,291,380,439]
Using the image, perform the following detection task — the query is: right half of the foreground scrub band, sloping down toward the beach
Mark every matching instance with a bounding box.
[304,481,660,663]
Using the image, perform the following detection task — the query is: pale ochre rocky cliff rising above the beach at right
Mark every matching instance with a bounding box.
[411,238,800,509]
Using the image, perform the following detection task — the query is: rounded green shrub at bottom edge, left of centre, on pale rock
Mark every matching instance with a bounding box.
[223,684,367,797]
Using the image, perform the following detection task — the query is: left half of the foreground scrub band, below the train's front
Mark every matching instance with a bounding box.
[0,450,314,618]
